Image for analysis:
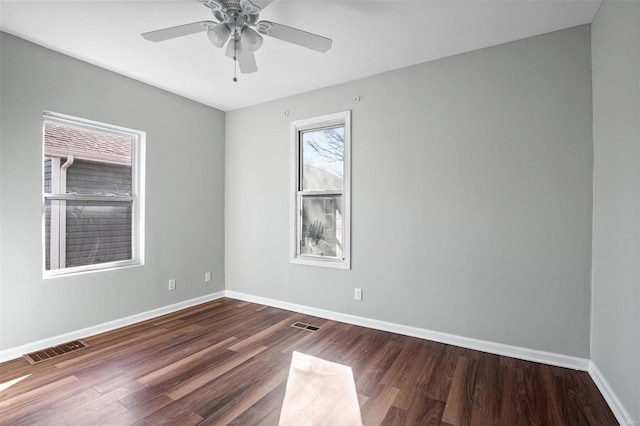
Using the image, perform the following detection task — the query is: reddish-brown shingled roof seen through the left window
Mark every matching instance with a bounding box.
[44,122,132,166]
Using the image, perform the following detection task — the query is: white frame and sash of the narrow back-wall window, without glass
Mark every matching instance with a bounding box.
[290,110,351,269]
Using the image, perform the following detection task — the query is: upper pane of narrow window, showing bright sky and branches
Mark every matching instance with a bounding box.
[300,126,344,191]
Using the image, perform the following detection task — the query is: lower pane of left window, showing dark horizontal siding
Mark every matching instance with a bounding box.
[45,200,133,269]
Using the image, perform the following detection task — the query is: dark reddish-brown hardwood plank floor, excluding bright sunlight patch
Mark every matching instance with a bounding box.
[0,299,618,426]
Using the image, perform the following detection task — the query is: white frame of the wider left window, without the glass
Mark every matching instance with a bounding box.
[41,111,146,278]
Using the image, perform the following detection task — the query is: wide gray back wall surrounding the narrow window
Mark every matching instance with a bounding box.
[225,26,593,357]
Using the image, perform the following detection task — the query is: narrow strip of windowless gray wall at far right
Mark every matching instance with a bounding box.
[591,1,640,421]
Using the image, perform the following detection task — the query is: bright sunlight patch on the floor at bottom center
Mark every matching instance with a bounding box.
[280,352,362,426]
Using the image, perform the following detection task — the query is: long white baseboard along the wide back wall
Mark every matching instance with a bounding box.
[225,290,590,371]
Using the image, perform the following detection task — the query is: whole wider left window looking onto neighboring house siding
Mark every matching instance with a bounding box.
[43,113,145,276]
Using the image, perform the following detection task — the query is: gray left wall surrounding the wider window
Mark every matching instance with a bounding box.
[0,34,224,349]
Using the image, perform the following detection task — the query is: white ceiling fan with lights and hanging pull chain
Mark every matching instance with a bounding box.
[142,0,332,81]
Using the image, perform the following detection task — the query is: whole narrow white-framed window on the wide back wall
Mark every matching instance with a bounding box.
[291,111,351,269]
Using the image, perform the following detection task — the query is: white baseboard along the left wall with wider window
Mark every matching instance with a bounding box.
[0,291,225,362]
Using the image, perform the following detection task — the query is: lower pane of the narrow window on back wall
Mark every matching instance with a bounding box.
[300,195,343,259]
